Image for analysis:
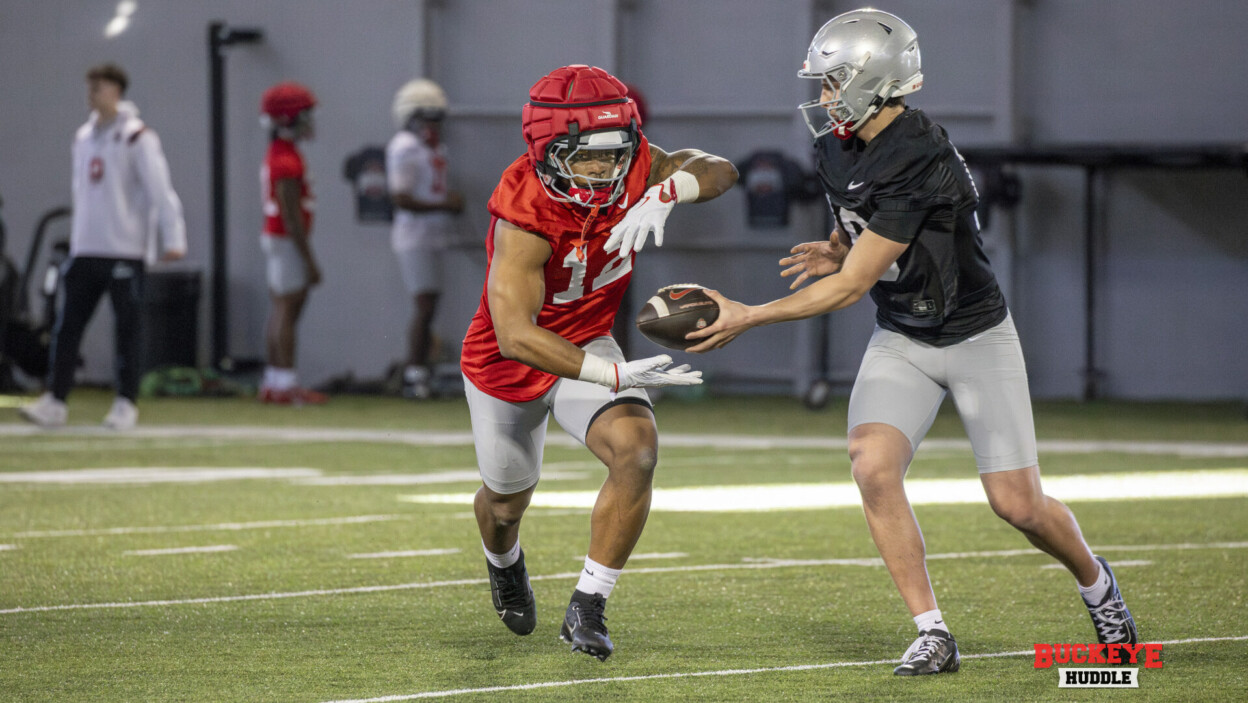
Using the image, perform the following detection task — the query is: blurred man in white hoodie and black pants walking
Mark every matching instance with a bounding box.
[21,64,186,430]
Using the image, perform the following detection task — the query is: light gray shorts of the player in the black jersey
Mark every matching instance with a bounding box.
[849,316,1040,473]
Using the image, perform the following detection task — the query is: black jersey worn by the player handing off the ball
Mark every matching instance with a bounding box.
[815,109,1006,346]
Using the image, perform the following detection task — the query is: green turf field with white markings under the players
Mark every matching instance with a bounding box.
[0,391,1248,703]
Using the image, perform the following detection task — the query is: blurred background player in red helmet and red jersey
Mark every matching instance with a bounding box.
[258,81,328,405]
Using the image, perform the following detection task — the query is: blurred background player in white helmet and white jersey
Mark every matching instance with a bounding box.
[386,79,464,398]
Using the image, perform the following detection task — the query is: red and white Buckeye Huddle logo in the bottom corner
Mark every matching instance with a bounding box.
[1032,644,1164,688]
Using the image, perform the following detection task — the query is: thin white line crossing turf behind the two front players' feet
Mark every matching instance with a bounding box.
[0,542,1248,616]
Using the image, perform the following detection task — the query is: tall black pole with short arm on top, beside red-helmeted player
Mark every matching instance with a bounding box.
[208,22,265,368]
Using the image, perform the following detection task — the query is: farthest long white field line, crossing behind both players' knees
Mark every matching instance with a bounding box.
[7,423,1248,458]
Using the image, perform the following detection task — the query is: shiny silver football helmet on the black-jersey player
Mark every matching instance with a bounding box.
[797,9,924,139]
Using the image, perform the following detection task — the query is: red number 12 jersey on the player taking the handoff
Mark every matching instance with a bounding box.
[459,137,650,402]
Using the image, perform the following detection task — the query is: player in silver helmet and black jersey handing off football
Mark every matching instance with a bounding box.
[689,9,1138,676]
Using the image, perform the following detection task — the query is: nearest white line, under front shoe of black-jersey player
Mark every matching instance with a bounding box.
[316,636,1248,703]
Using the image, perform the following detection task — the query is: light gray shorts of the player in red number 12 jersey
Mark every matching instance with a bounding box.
[464,337,650,496]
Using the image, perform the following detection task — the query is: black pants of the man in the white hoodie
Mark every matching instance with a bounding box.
[47,256,145,402]
